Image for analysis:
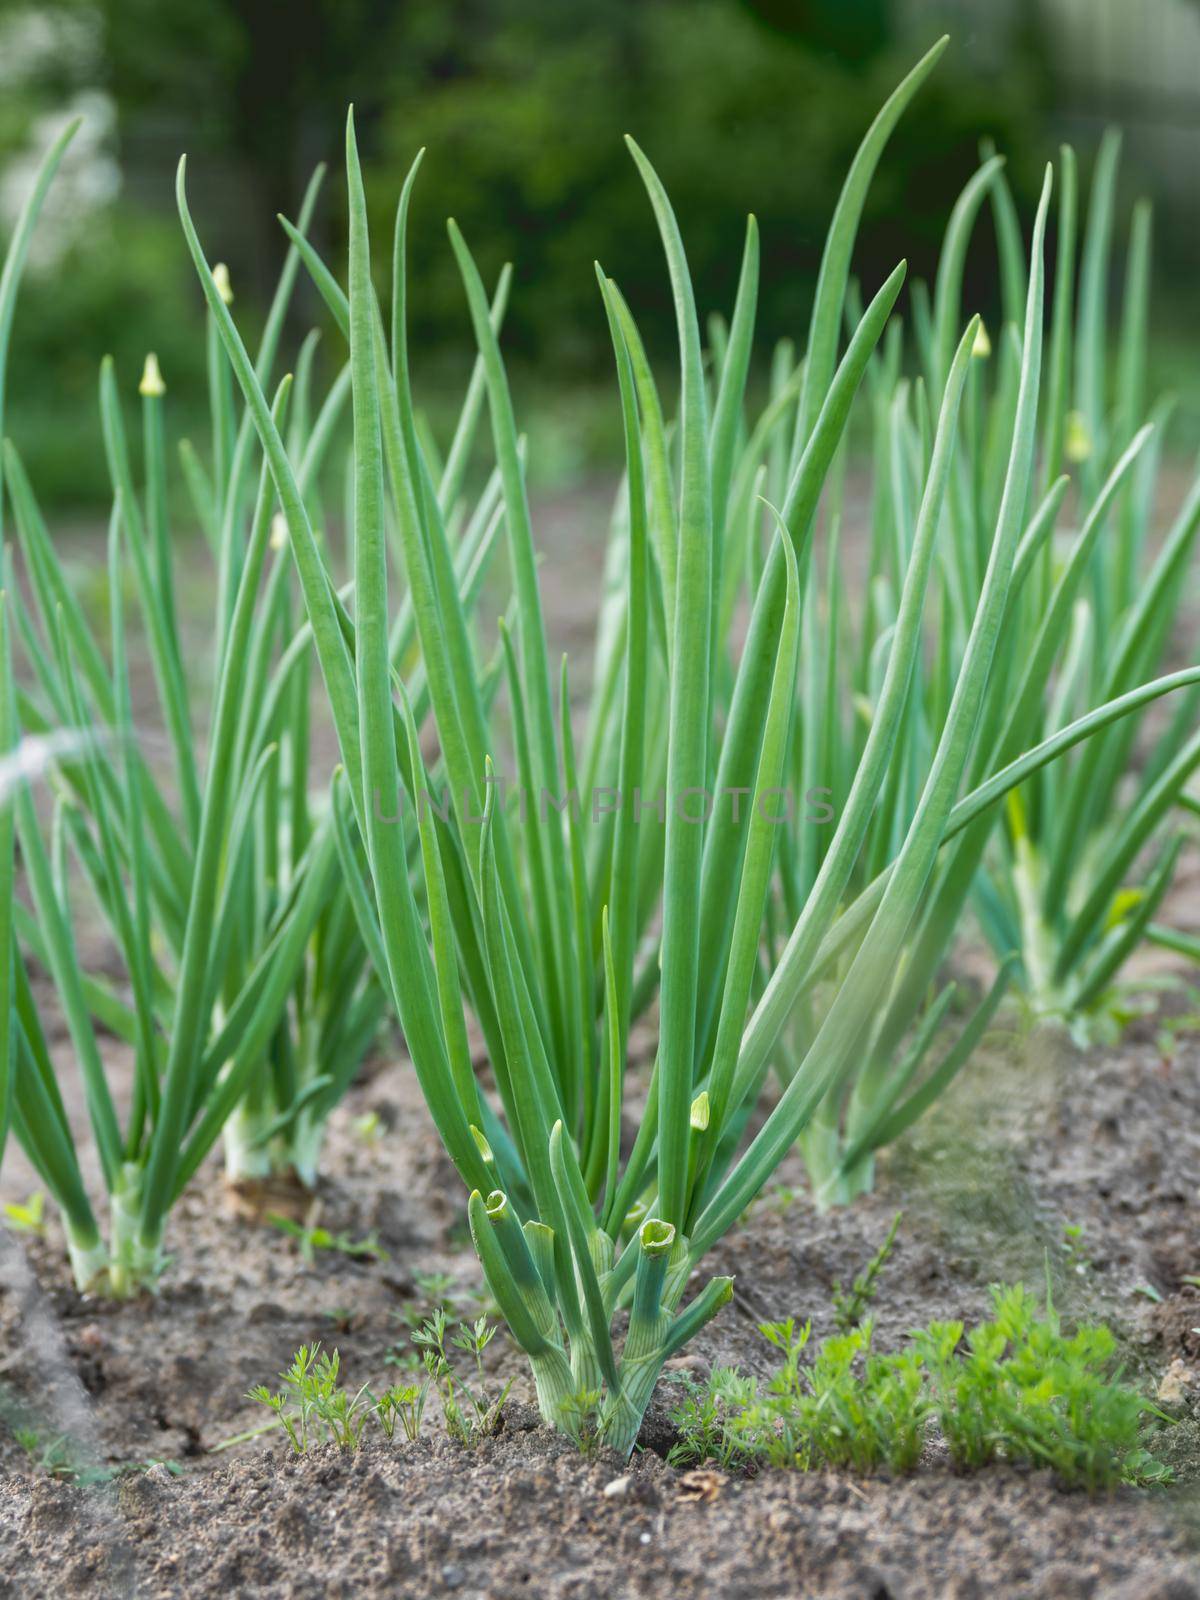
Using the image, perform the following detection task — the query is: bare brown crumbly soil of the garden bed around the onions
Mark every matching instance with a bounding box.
[0,992,1200,1600]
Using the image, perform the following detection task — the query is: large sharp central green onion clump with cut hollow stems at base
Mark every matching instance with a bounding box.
[178,45,1200,1453]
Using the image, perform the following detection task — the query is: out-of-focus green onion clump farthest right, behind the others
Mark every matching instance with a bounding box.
[976,140,1200,1037]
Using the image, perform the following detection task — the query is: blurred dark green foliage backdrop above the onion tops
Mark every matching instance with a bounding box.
[0,0,1200,509]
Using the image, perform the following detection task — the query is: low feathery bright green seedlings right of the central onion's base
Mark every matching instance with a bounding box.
[670,1283,1173,1493]
